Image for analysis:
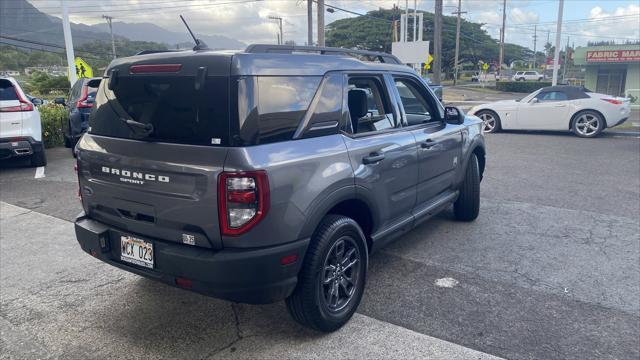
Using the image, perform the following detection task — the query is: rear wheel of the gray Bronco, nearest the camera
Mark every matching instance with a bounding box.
[286,215,368,332]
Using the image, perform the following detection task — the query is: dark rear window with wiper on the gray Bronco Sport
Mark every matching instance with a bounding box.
[88,74,229,146]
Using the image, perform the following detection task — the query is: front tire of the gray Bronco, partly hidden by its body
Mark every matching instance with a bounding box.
[453,154,480,221]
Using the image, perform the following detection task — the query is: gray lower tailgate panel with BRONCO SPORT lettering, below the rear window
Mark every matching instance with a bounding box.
[78,134,227,249]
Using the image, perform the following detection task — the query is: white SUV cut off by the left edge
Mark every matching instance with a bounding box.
[0,77,47,166]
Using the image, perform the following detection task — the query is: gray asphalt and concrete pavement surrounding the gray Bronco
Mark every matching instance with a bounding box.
[0,132,640,359]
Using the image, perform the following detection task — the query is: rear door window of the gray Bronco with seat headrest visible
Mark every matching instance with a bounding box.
[347,77,396,134]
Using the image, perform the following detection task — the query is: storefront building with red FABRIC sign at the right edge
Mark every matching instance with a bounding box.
[573,44,640,104]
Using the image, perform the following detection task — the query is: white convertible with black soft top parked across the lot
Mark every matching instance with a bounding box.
[469,86,631,137]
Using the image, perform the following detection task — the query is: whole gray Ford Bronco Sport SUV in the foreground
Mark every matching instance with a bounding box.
[75,45,485,331]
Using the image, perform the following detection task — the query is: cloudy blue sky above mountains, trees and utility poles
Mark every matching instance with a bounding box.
[27,0,640,48]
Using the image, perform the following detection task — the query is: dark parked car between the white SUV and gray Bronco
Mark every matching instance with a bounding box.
[54,78,102,148]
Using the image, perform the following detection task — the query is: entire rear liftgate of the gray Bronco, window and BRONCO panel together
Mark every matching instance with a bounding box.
[78,51,230,249]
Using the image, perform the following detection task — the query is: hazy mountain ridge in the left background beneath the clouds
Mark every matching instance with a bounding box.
[0,0,246,50]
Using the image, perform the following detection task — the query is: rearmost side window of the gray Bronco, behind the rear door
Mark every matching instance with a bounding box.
[238,76,321,145]
